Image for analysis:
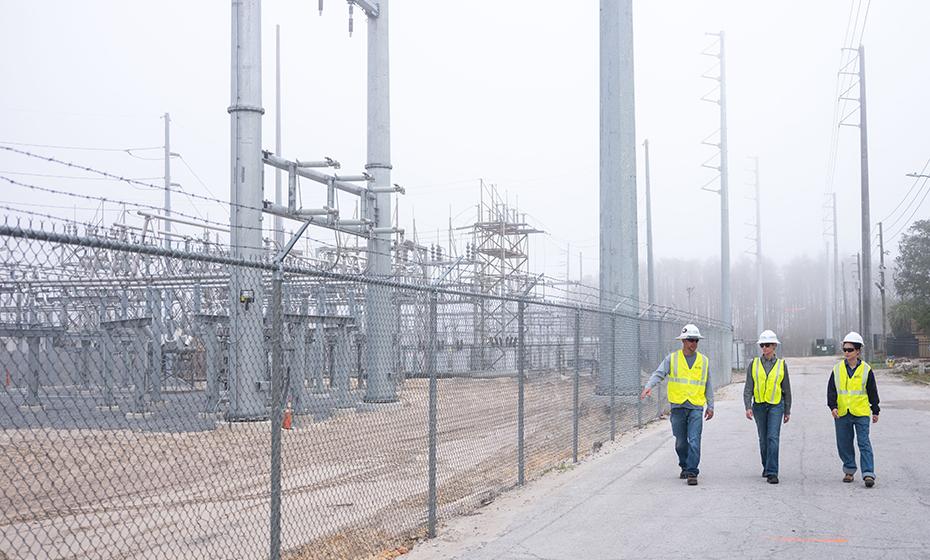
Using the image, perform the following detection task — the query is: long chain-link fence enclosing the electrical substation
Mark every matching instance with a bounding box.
[0,226,729,559]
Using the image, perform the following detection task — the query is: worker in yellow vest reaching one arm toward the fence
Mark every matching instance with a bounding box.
[639,324,714,486]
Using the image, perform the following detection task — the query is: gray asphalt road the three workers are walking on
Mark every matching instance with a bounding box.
[405,358,930,560]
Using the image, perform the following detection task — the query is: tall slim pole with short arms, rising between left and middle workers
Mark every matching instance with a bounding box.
[720,31,733,372]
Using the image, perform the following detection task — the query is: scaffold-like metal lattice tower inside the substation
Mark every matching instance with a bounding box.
[471,181,543,371]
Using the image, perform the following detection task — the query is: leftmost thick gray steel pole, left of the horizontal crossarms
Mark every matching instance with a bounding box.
[227,0,270,420]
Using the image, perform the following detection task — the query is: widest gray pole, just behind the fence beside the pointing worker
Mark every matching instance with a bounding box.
[596,0,640,395]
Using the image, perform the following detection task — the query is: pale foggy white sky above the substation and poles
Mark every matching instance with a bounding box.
[0,0,930,284]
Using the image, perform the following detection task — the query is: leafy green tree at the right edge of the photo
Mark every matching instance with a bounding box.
[894,220,930,330]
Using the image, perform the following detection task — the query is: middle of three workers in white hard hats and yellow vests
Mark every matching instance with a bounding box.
[743,330,791,484]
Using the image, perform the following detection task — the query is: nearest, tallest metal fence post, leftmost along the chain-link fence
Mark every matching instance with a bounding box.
[269,263,284,560]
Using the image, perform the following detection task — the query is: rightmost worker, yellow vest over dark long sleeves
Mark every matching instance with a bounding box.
[827,332,881,488]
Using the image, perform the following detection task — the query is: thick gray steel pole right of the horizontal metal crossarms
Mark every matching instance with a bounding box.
[364,0,397,403]
